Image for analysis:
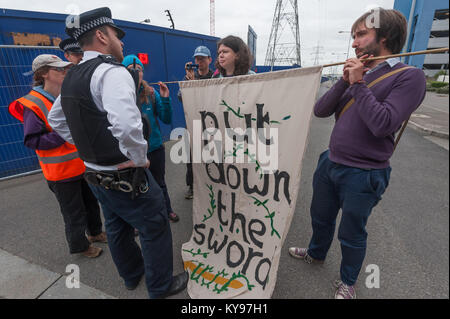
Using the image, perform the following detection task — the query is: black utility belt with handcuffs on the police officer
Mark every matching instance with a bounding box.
[84,167,149,199]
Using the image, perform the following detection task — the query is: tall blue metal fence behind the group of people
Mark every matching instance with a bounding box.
[0,9,218,178]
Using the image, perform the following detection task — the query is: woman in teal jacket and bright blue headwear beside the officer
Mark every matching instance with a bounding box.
[122,54,179,222]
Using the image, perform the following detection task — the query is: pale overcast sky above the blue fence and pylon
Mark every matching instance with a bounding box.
[0,0,394,73]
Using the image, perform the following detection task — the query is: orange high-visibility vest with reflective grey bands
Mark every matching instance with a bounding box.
[8,90,86,182]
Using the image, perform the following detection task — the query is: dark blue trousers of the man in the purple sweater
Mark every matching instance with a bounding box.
[308,151,391,286]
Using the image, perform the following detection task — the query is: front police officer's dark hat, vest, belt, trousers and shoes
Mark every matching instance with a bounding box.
[61,8,188,298]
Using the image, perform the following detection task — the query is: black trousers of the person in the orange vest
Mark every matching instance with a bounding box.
[47,179,102,254]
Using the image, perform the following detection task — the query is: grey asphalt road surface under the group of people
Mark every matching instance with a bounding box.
[0,112,449,298]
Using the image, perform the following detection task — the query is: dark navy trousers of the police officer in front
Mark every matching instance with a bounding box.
[90,170,173,298]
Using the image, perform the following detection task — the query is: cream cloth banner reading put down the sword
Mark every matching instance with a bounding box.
[179,67,322,298]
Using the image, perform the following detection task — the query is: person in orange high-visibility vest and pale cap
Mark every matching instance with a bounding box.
[9,54,106,258]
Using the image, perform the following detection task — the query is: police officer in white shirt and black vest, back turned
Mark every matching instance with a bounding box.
[49,7,188,298]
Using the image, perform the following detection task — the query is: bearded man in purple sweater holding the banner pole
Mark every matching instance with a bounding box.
[289,8,426,299]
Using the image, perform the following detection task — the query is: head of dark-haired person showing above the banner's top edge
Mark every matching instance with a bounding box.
[213,35,255,78]
